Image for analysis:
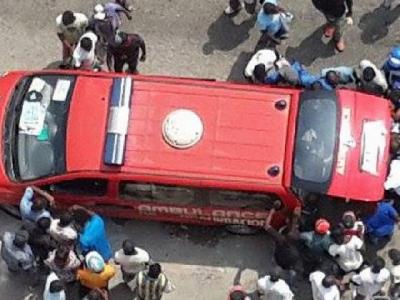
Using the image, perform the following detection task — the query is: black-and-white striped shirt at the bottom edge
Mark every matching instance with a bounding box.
[136,271,174,300]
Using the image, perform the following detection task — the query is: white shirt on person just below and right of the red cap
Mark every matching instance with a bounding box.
[328,236,364,272]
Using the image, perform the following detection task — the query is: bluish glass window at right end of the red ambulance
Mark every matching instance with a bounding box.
[293,91,337,192]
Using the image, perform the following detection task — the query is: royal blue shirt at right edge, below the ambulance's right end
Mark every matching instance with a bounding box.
[366,202,398,237]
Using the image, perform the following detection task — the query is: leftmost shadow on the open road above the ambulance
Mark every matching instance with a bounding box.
[203,13,256,55]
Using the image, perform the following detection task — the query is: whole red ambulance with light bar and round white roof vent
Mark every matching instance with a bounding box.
[0,71,391,226]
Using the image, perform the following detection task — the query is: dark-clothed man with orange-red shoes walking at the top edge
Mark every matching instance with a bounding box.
[312,0,353,52]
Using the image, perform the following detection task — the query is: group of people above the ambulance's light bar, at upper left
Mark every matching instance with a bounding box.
[56,0,146,74]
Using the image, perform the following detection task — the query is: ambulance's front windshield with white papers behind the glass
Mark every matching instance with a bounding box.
[5,75,75,180]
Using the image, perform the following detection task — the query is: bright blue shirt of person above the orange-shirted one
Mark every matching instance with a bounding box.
[79,215,112,261]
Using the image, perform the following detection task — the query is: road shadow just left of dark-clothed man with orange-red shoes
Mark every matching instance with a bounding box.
[285,26,335,66]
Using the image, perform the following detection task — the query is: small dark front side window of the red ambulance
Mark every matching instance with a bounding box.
[49,178,107,196]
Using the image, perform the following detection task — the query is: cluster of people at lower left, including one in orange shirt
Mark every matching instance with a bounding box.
[1,186,174,300]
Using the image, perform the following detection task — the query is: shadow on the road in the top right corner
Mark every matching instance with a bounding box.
[358,5,400,44]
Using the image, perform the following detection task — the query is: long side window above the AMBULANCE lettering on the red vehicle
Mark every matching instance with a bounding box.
[119,181,280,209]
